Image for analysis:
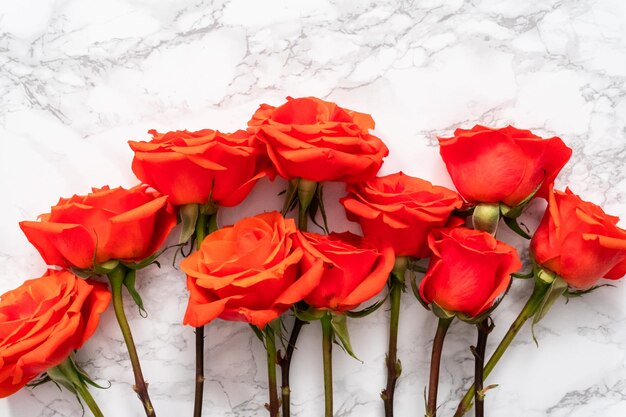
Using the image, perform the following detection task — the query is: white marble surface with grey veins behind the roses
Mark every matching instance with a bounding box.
[0,0,626,417]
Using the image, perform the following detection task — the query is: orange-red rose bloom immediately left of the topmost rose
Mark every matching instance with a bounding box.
[128,130,269,207]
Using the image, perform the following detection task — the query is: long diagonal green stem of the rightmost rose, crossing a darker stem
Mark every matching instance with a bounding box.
[454,281,550,417]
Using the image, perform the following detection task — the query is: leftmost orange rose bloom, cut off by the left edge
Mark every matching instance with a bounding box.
[0,270,111,397]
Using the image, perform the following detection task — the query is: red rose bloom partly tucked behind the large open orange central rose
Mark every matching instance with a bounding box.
[300,232,395,312]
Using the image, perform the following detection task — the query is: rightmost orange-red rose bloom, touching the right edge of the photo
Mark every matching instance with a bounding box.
[530,189,626,289]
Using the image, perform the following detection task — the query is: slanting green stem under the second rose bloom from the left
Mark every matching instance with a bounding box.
[108,264,156,417]
